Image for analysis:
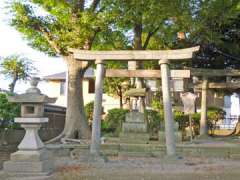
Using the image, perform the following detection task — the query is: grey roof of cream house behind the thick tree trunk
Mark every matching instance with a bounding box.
[43,68,94,80]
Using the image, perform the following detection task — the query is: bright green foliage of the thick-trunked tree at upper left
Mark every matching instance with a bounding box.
[10,0,121,56]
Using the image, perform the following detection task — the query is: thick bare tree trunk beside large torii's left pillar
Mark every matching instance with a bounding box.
[63,55,90,138]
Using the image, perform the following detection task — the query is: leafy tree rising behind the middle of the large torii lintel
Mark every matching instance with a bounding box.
[104,0,193,113]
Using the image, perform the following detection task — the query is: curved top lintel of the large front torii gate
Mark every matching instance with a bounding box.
[69,46,199,61]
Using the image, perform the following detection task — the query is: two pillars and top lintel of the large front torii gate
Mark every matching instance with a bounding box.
[70,46,199,156]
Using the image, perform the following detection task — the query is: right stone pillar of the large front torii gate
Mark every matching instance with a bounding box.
[159,60,176,156]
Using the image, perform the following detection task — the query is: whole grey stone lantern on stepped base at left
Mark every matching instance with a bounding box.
[3,77,56,176]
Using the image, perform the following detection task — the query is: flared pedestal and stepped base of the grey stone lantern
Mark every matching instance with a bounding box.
[3,118,53,176]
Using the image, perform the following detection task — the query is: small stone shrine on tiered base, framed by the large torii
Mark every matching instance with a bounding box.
[120,88,149,144]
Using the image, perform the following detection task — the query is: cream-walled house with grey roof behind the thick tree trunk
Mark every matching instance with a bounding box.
[44,68,120,112]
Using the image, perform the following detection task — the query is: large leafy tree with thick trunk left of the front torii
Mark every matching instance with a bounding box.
[8,0,112,139]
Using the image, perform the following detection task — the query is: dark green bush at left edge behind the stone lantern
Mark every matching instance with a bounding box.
[0,93,20,128]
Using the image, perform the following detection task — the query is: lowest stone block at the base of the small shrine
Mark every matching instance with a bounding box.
[119,133,150,144]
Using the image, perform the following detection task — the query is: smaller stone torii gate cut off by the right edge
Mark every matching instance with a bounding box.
[191,68,240,137]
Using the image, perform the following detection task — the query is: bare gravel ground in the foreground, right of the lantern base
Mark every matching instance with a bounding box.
[54,157,240,180]
